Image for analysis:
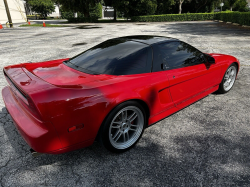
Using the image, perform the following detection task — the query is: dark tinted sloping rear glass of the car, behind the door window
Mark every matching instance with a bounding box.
[70,40,150,75]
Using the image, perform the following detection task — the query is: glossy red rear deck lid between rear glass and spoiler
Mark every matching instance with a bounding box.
[24,59,117,88]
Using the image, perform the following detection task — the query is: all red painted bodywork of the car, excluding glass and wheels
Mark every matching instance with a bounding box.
[2,51,238,154]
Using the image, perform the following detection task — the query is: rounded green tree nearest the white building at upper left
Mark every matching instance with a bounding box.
[28,0,55,18]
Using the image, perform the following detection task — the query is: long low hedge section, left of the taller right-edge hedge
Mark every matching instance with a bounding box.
[131,13,216,22]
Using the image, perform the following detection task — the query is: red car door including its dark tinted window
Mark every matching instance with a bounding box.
[154,41,221,108]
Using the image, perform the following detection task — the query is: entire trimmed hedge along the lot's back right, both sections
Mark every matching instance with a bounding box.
[131,12,250,26]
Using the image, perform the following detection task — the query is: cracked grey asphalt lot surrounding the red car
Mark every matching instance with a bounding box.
[0,22,250,187]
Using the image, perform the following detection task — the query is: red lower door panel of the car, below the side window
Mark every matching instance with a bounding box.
[167,64,221,108]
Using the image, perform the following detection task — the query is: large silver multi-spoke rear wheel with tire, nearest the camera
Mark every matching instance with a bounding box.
[100,101,146,153]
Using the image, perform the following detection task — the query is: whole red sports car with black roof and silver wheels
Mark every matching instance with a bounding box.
[2,36,240,154]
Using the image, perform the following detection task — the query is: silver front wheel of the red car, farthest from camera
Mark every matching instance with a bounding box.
[218,64,237,93]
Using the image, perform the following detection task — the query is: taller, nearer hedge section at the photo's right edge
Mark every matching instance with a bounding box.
[215,12,250,26]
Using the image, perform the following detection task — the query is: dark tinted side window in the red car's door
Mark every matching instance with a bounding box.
[153,41,205,71]
